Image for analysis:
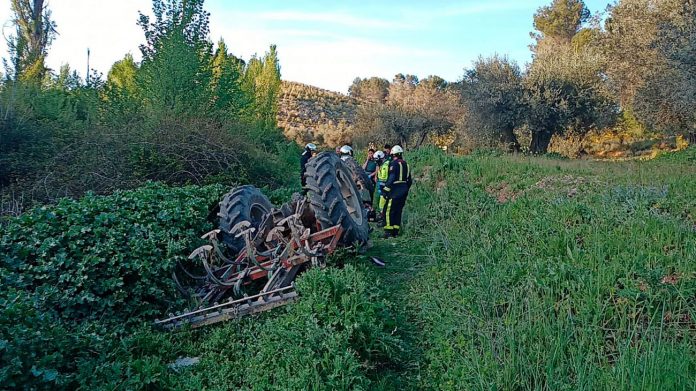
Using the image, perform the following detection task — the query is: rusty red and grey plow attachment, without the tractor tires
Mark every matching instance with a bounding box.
[155,198,343,329]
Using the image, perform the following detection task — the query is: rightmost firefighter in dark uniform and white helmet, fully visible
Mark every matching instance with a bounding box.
[382,145,413,238]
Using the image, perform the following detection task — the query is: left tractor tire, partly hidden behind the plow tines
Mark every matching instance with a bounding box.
[218,186,273,254]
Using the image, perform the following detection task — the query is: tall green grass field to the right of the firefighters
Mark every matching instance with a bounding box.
[364,150,696,390]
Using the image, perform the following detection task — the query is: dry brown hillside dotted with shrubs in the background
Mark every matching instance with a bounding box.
[278,81,358,146]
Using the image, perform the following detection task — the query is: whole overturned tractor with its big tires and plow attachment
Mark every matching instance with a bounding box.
[155,152,369,328]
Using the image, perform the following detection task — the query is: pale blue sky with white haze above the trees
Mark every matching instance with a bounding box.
[0,0,608,92]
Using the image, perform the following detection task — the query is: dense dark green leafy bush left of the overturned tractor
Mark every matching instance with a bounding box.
[0,184,225,386]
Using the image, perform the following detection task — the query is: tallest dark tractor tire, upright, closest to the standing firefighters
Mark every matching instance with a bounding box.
[305,152,369,245]
